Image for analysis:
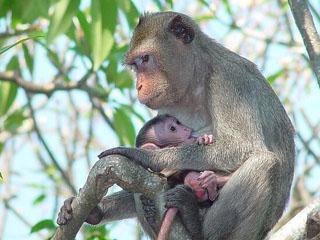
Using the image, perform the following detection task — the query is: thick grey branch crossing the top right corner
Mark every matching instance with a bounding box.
[289,0,320,86]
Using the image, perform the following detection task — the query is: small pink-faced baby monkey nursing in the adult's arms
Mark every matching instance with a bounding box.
[136,115,229,240]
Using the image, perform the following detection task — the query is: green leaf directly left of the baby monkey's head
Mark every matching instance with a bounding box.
[113,108,135,146]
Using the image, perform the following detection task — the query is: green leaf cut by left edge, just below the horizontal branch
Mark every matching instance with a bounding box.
[0,82,17,116]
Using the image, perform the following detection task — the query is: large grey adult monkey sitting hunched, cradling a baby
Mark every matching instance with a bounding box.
[98,12,295,240]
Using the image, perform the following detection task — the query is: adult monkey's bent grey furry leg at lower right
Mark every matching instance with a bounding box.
[203,152,290,240]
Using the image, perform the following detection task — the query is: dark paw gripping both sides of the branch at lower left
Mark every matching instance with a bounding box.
[57,197,103,225]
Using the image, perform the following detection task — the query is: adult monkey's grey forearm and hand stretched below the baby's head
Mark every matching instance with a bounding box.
[99,138,253,173]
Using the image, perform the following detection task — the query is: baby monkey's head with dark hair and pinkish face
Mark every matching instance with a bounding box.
[136,114,197,150]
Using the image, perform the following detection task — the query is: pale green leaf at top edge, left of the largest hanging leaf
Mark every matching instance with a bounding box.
[47,0,80,44]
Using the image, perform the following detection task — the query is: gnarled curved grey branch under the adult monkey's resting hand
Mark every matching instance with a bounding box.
[53,155,190,240]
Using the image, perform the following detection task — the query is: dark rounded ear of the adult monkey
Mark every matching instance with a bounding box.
[169,15,194,44]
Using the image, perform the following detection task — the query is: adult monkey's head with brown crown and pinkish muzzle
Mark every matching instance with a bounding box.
[125,12,195,109]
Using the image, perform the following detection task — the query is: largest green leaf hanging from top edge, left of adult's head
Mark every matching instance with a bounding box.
[90,0,117,71]
